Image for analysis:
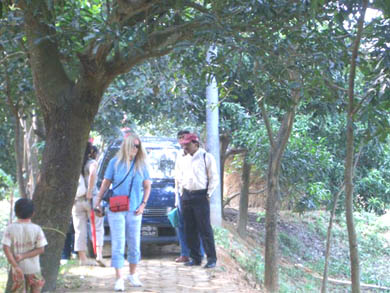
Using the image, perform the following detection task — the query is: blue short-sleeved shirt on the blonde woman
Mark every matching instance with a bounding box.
[104,157,150,211]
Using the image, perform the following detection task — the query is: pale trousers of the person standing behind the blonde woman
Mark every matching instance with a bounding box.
[72,196,104,251]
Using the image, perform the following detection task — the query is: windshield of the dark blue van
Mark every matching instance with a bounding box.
[146,147,177,179]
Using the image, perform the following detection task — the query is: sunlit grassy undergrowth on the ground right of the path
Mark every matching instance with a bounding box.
[215,211,390,292]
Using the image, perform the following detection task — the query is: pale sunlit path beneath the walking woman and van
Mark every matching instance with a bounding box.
[56,246,259,293]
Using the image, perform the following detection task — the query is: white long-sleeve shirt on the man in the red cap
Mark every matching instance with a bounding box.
[178,148,219,197]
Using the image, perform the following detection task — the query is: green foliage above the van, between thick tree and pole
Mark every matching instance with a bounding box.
[93,53,205,138]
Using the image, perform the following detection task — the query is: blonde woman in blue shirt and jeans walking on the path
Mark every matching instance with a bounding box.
[95,133,152,291]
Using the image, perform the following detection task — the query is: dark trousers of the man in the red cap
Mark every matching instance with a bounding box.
[181,190,217,262]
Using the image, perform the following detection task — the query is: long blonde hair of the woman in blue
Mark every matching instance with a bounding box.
[116,133,147,171]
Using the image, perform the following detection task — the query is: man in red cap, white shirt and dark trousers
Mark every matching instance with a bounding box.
[179,133,219,268]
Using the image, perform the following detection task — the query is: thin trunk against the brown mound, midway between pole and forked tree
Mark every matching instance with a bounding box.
[237,152,251,238]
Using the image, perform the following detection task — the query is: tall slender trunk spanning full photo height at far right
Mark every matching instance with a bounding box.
[344,0,368,293]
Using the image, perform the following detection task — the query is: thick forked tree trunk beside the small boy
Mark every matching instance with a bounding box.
[18,1,115,292]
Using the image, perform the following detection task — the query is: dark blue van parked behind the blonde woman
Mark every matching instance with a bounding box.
[88,137,180,254]
